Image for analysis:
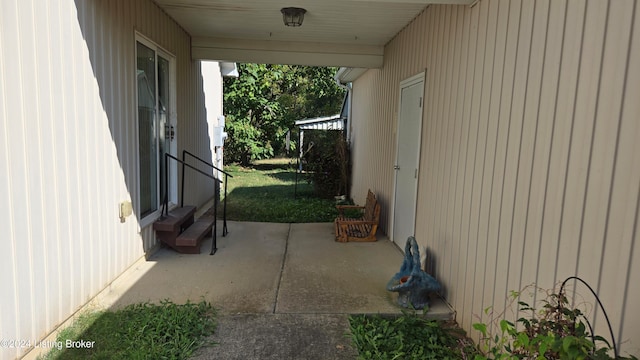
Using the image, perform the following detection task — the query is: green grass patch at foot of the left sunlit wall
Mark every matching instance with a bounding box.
[44,301,216,360]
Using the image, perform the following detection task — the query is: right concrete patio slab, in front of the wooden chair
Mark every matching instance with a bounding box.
[276,223,403,314]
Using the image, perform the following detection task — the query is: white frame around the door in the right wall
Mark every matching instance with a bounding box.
[389,69,427,246]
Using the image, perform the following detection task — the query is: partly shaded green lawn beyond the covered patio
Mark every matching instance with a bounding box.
[220,159,337,223]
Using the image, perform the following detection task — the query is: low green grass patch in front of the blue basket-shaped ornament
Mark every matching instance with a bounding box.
[349,313,476,360]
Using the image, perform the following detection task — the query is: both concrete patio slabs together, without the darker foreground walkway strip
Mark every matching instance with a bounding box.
[93,221,452,319]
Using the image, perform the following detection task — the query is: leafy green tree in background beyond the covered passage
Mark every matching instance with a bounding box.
[224,64,344,165]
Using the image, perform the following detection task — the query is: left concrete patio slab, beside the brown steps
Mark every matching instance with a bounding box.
[104,222,289,314]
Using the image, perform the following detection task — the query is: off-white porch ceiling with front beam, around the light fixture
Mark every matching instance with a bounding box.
[154,0,474,68]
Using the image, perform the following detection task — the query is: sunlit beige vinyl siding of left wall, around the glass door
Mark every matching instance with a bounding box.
[0,0,213,359]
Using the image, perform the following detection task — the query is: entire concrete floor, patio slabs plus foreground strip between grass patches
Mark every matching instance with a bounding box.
[87,222,452,360]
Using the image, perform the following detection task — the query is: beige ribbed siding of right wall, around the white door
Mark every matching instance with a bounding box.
[352,0,640,355]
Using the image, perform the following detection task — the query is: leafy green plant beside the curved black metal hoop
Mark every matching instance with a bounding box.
[473,281,637,360]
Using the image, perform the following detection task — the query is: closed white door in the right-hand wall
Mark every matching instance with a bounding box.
[393,73,424,249]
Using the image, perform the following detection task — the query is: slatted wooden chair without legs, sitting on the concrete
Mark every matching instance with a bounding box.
[334,190,380,242]
